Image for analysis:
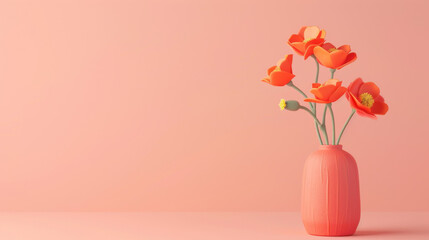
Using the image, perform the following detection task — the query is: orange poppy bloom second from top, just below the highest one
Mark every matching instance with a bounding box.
[313,43,357,69]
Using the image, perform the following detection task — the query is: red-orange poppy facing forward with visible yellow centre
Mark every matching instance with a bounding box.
[346,78,389,119]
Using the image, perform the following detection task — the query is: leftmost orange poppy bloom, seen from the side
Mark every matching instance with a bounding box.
[262,54,295,86]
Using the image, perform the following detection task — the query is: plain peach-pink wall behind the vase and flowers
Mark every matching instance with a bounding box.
[0,0,429,211]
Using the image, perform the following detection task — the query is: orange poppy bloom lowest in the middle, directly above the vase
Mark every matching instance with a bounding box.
[304,79,347,103]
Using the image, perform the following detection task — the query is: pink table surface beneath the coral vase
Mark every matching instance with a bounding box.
[0,212,429,240]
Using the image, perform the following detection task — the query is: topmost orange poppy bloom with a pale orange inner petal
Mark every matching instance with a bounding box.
[288,26,326,59]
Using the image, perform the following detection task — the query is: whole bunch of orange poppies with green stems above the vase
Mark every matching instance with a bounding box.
[262,26,389,145]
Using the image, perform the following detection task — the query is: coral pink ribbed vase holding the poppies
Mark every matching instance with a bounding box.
[301,145,360,236]
